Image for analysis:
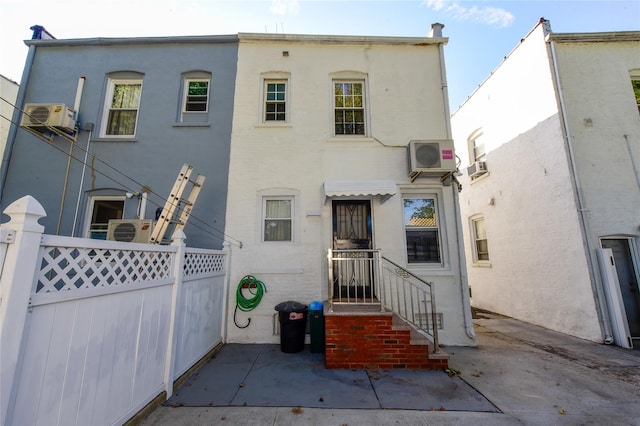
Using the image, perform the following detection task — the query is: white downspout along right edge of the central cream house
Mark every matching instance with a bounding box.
[429,23,476,340]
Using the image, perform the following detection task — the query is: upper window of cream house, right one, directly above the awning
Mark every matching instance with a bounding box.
[333,80,366,135]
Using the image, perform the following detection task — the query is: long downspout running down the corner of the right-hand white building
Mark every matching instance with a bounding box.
[545,35,613,345]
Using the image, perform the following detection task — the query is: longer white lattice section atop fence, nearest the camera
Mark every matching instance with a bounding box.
[36,246,173,293]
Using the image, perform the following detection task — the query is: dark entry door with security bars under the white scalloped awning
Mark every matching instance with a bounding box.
[333,200,374,299]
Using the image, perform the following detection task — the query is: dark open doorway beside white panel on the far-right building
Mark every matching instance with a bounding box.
[602,238,640,339]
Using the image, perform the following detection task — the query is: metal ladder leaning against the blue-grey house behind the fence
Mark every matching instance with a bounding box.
[149,164,205,245]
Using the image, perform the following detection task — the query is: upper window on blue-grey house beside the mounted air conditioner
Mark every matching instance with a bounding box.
[102,78,142,137]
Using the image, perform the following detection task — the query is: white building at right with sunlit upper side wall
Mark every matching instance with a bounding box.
[452,19,640,346]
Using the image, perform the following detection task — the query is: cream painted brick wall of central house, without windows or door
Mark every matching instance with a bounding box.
[226,36,470,344]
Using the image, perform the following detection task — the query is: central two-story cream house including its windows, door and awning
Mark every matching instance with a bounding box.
[225,24,475,345]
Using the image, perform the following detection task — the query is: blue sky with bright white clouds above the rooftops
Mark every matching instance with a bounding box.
[0,0,640,112]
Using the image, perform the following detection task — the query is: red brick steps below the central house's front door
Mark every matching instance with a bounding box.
[324,304,449,370]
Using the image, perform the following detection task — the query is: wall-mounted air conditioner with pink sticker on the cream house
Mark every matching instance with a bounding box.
[408,140,456,176]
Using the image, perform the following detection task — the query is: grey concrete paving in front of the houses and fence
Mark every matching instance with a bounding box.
[143,314,640,426]
